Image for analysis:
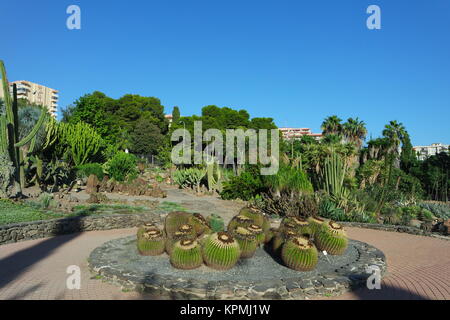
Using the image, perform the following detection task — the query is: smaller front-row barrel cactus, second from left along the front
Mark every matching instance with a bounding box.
[170,240,203,270]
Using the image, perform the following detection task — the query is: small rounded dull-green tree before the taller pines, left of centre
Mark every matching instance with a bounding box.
[131,117,164,155]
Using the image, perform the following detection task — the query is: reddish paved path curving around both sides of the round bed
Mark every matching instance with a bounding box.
[0,228,450,300]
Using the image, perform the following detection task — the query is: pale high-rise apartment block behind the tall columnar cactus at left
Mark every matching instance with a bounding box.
[0,80,59,117]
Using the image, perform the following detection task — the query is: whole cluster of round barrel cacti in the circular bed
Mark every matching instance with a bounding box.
[137,207,348,271]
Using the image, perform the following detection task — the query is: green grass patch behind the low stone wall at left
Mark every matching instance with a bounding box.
[0,200,64,225]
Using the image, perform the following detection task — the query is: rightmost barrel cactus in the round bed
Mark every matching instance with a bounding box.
[315,221,348,255]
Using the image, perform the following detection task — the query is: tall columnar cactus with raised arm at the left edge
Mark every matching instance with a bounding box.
[0,60,48,193]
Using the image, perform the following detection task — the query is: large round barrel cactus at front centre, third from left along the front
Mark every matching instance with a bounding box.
[203,232,241,270]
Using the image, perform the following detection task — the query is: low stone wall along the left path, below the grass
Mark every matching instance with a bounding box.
[0,213,161,245]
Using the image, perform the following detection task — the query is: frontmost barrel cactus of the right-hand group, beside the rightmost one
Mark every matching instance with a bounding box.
[281,237,319,271]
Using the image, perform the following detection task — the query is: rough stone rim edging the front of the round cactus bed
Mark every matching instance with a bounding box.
[88,237,387,300]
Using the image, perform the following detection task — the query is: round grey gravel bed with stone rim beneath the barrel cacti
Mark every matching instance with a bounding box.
[89,236,386,300]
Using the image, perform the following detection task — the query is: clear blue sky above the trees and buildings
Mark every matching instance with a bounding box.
[0,0,450,145]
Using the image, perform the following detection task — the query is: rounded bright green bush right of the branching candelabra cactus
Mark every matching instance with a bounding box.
[105,151,138,181]
